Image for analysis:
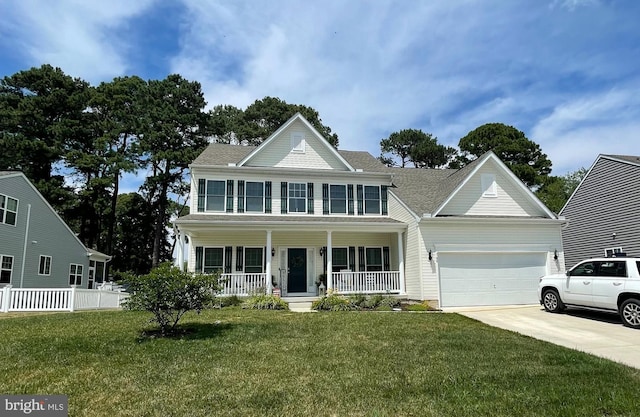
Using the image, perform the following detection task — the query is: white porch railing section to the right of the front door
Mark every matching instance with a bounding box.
[331,271,400,294]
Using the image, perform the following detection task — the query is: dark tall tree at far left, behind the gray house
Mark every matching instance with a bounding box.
[0,65,89,212]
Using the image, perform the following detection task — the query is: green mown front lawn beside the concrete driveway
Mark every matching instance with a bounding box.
[0,308,640,417]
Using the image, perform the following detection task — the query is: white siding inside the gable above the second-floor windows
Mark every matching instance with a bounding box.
[246,120,347,171]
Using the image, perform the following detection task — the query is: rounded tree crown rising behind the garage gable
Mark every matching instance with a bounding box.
[458,123,551,187]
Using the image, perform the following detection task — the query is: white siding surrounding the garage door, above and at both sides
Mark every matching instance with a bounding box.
[420,219,564,300]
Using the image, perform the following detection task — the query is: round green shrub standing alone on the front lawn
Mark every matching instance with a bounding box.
[123,263,218,336]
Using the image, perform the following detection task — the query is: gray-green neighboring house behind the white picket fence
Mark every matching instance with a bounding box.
[0,171,110,288]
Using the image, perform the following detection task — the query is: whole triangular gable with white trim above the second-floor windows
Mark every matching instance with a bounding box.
[236,113,357,172]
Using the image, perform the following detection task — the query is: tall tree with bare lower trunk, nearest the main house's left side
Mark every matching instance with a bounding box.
[140,74,209,267]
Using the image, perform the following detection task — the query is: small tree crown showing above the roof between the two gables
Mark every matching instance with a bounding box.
[379,129,457,168]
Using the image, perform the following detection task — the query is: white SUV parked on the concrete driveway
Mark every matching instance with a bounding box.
[538,257,640,329]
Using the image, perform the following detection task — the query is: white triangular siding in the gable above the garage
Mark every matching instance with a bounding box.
[440,161,546,217]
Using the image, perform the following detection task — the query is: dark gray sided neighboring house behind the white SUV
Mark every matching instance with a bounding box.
[560,155,640,267]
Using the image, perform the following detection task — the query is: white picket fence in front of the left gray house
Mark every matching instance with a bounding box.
[0,285,129,313]
